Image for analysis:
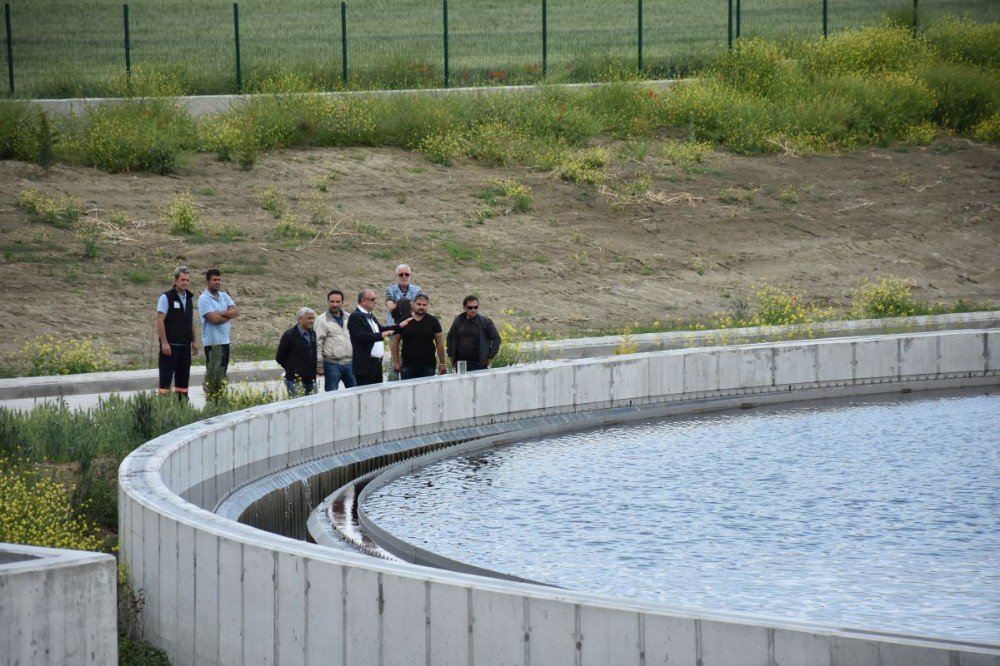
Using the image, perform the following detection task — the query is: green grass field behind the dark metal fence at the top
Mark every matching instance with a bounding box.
[0,0,1000,97]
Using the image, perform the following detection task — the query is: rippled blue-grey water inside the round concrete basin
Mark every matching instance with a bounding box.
[365,395,1000,642]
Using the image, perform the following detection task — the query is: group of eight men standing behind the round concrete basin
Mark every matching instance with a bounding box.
[157,264,501,397]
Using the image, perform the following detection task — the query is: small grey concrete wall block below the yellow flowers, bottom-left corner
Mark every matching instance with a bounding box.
[0,544,118,666]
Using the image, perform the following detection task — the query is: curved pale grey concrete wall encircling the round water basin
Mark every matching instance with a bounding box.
[119,329,1000,666]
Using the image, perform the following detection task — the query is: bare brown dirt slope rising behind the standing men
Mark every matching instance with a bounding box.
[0,139,1000,364]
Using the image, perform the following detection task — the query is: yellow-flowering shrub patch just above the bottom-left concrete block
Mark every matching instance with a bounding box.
[0,459,104,550]
